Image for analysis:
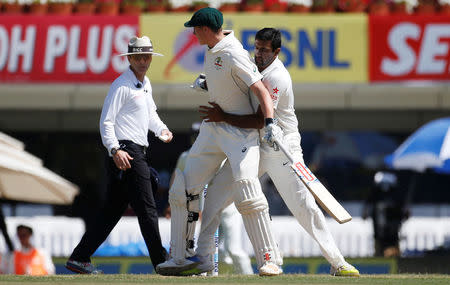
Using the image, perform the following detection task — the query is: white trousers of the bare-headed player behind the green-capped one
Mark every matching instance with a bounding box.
[197,133,345,268]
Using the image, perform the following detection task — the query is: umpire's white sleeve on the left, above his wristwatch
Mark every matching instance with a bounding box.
[100,86,126,153]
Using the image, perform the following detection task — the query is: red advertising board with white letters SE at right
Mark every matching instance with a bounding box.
[369,15,450,81]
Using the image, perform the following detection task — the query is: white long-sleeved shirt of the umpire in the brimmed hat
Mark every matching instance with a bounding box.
[100,68,168,154]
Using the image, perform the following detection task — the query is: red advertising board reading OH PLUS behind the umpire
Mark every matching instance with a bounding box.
[0,15,139,83]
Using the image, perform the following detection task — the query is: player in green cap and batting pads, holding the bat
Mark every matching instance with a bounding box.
[156,8,281,275]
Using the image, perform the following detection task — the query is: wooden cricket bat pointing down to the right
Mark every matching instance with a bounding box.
[275,140,352,224]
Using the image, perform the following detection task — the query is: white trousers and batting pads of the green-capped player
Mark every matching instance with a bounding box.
[169,119,281,268]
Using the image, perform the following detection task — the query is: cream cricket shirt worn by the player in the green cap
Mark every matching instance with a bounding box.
[204,31,262,115]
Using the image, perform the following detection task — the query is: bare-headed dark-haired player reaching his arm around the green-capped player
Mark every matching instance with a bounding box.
[192,28,359,276]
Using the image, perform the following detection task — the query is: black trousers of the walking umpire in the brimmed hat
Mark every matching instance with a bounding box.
[70,141,167,268]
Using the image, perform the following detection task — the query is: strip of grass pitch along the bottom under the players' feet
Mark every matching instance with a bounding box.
[0,274,450,285]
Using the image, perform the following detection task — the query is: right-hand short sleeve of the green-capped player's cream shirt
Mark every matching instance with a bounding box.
[231,51,262,87]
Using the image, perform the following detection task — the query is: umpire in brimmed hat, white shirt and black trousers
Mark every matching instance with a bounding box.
[66,36,172,274]
